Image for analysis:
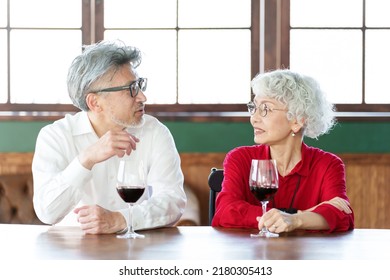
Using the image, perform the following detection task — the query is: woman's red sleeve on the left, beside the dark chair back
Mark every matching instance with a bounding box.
[211,148,262,228]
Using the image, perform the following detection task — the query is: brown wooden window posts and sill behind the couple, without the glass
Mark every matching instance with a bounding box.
[0,0,390,122]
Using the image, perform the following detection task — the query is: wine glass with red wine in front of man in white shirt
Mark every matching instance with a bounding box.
[116,159,146,239]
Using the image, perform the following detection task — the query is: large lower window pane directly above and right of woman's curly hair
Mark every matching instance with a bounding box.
[290,30,362,103]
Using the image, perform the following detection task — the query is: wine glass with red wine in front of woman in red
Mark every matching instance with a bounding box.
[249,159,279,237]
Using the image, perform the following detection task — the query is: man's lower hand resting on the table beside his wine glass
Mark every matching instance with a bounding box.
[74,205,126,234]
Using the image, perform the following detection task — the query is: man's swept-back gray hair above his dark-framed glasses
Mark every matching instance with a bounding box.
[67,41,141,111]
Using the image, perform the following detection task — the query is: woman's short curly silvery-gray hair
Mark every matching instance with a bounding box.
[251,69,336,139]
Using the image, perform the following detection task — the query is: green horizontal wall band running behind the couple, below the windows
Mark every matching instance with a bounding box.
[0,121,390,153]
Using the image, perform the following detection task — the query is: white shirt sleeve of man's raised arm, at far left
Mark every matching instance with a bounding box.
[32,127,92,224]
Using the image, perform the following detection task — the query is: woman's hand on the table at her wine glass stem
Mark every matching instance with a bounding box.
[257,208,298,233]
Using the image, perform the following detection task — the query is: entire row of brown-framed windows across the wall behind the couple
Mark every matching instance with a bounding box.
[0,0,390,121]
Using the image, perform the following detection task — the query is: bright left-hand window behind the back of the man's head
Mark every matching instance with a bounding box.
[0,0,82,115]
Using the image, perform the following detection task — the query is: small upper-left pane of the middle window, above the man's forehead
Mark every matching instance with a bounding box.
[104,0,177,28]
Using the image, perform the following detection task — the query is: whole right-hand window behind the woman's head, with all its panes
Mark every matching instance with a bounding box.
[288,0,390,116]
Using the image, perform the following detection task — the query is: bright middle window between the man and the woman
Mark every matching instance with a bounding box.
[104,0,251,104]
